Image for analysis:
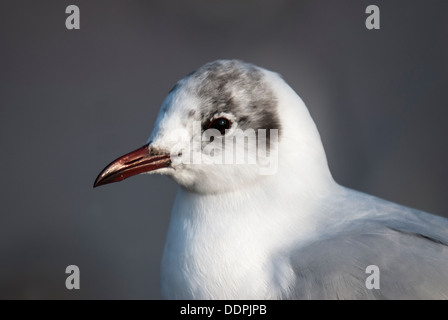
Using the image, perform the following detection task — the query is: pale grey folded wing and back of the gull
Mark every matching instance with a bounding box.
[285,190,448,299]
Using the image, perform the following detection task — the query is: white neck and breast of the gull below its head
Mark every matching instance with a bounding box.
[162,172,334,299]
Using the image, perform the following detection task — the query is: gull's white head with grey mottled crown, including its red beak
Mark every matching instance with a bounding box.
[94,60,329,194]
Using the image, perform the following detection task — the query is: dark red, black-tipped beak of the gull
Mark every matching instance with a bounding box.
[93,144,171,188]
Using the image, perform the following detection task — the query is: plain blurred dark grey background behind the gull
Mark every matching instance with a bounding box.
[0,0,448,299]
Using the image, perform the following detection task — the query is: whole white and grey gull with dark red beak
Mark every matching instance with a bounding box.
[94,60,448,299]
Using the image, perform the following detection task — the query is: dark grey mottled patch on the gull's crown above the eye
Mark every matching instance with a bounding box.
[172,60,281,138]
